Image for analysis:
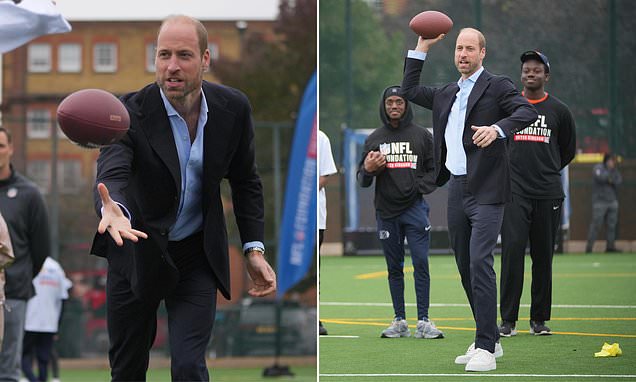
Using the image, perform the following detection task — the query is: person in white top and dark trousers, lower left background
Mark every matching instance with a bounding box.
[22,257,72,382]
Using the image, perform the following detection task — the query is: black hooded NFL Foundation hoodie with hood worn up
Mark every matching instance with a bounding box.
[357,86,436,219]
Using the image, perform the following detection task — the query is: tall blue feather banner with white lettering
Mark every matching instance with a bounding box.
[276,73,318,298]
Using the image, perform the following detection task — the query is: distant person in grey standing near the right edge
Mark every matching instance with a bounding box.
[585,153,623,253]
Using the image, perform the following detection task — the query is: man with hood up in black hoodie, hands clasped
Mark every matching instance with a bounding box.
[358,86,444,338]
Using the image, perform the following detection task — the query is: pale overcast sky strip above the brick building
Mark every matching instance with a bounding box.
[55,0,280,21]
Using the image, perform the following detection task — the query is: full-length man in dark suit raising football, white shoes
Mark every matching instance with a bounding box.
[402,28,537,371]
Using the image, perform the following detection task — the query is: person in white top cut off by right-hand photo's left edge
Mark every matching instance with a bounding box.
[318,130,338,336]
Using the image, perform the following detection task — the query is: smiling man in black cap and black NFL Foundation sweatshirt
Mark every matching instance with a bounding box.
[499,51,576,337]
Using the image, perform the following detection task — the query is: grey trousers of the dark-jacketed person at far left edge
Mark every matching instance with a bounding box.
[0,299,27,382]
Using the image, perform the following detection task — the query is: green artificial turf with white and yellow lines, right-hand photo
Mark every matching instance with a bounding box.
[319,253,636,382]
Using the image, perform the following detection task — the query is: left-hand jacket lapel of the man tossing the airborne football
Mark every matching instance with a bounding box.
[140,86,181,190]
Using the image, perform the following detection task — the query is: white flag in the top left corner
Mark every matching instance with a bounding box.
[0,0,71,54]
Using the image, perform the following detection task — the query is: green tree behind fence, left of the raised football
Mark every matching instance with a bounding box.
[319,0,403,143]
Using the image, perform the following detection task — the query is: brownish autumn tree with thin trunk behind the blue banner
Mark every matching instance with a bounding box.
[215,0,317,253]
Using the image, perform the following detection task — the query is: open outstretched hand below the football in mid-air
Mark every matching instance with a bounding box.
[97,183,148,247]
